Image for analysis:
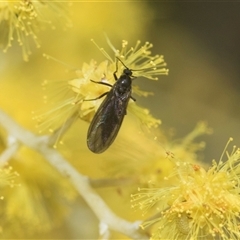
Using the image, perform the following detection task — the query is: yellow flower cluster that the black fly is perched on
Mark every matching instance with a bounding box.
[35,40,168,146]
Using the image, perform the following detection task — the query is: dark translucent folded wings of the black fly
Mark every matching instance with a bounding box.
[87,89,131,153]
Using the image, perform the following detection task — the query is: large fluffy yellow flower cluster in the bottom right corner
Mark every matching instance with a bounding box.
[133,139,240,240]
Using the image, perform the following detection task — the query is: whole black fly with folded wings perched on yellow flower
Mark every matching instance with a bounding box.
[85,58,136,153]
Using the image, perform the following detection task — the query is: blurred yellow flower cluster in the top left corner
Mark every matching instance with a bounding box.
[0,0,69,61]
